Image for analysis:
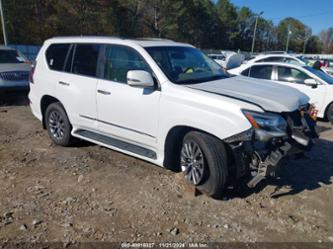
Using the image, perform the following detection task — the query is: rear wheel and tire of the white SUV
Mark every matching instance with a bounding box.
[45,102,74,146]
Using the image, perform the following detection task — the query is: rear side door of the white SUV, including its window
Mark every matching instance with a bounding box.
[57,43,101,129]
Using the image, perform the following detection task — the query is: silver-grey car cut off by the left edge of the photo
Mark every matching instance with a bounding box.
[0,46,31,91]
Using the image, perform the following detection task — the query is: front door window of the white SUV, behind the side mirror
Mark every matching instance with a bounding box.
[103,45,151,83]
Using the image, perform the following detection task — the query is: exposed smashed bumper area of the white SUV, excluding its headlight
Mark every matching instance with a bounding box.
[224,110,318,187]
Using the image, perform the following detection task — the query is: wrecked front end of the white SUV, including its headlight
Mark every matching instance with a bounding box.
[224,105,318,187]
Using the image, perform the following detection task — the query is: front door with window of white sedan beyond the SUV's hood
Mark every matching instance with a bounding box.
[275,66,326,110]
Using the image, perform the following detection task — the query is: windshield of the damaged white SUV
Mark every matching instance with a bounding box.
[145,46,229,84]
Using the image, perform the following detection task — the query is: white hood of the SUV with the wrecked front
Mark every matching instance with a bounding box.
[186,76,309,113]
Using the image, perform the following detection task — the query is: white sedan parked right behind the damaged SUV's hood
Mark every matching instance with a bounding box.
[228,62,333,122]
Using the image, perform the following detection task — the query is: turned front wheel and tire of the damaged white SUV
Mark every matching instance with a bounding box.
[180,131,228,198]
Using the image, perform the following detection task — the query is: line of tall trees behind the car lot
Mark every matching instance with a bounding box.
[2,0,333,53]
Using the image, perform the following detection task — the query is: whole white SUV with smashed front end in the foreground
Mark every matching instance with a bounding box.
[29,37,316,197]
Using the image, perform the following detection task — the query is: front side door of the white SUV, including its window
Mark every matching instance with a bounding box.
[97,45,160,149]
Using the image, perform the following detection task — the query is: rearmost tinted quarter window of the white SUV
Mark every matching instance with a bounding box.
[46,43,70,71]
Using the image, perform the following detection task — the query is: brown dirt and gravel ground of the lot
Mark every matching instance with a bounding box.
[0,93,333,243]
